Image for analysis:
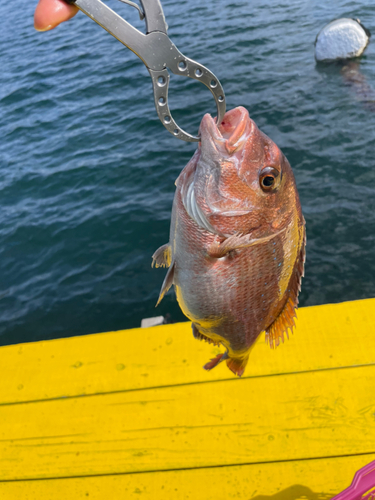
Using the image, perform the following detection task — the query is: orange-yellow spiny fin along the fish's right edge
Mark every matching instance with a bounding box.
[266,225,306,349]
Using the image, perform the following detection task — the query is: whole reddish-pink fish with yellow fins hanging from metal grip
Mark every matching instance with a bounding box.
[152,106,306,376]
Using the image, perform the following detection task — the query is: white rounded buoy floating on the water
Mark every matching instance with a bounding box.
[315,18,371,61]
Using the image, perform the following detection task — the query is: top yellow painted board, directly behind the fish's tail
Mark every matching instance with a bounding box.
[0,299,375,404]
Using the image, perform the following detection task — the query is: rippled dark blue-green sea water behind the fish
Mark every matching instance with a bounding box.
[0,0,375,345]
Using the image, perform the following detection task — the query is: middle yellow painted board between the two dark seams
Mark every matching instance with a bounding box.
[0,366,375,480]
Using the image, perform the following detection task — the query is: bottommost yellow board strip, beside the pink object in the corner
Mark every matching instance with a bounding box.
[0,454,375,500]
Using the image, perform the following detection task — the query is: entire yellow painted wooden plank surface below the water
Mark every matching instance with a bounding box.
[0,299,375,500]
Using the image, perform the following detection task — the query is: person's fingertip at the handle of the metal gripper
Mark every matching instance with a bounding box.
[34,0,78,31]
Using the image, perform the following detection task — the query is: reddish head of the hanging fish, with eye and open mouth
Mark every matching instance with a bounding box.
[180,107,299,237]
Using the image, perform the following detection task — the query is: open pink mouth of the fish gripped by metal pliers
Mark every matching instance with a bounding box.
[199,106,254,155]
